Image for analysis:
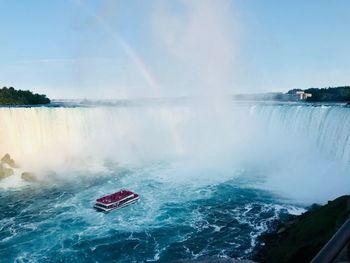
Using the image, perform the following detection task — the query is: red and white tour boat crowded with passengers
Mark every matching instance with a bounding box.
[94,189,140,212]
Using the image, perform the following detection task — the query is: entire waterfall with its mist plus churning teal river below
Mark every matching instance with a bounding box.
[0,102,350,262]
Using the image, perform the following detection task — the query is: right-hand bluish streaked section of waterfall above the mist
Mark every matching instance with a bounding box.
[251,105,350,165]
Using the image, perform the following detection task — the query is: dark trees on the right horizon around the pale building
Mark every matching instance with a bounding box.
[288,86,350,102]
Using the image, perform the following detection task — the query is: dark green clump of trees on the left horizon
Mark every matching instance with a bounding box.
[0,87,51,105]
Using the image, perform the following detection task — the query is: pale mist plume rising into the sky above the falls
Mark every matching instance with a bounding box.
[151,0,239,96]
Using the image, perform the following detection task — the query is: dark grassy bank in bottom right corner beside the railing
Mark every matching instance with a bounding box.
[253,195,350,263]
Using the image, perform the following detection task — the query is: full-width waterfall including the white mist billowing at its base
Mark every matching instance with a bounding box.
[0,103,350,201]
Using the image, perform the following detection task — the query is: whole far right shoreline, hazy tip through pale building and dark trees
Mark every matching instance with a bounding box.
[233,86,350,105]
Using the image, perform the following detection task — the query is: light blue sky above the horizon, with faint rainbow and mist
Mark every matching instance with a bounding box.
[0,0,350,98]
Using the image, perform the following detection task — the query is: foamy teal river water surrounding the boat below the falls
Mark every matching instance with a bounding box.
[0,164,300,262]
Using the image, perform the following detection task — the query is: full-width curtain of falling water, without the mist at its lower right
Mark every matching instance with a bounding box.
[0,104,350,173]
